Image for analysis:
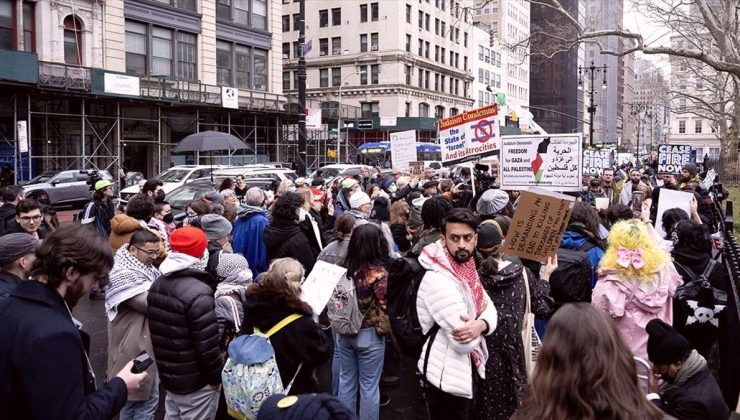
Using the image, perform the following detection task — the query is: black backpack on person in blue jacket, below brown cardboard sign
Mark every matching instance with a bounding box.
[550,242,596,313]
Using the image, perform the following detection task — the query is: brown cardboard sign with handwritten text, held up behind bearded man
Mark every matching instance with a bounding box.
[502,187,575,263]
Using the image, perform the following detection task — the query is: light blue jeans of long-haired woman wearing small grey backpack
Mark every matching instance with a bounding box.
[334,328,385,420]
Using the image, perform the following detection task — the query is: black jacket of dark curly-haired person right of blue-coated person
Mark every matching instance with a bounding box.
[262,218,319,275]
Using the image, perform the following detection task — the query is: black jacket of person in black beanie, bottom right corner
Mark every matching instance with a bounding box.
[653,367,730,420]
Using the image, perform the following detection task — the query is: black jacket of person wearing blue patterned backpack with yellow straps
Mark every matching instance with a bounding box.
[242,285,332,395]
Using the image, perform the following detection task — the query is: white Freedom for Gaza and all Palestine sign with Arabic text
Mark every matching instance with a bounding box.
[499,133,583,191]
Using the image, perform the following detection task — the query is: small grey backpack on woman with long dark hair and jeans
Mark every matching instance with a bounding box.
[326,273,364,335]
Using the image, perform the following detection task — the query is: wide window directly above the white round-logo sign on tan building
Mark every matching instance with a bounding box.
[216,40,267,90]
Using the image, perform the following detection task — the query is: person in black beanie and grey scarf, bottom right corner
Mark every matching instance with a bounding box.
[645,319,730,420]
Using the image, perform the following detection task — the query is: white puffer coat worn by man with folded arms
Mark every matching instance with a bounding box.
[416,242,497,399]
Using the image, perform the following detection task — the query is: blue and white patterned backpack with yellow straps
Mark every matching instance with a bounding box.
[221,314,303,419]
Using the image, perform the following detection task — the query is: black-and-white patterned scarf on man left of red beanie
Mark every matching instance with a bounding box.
[105,243,160,321]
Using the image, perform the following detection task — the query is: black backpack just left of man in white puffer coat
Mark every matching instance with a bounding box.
[386,257,426,360]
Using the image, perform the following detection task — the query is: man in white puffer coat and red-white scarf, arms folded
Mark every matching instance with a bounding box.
[416,209,497,419]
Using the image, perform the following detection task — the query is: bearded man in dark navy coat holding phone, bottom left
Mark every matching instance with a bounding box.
[0,224,146,420]
